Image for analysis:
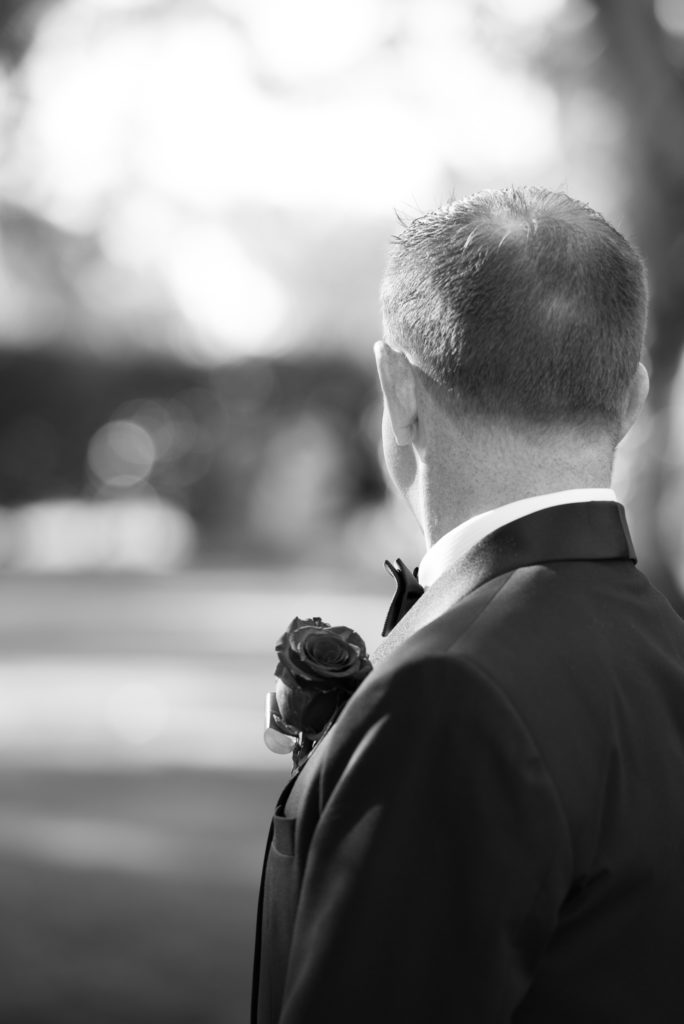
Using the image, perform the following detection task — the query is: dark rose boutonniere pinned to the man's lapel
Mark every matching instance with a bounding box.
[264,618,373,770]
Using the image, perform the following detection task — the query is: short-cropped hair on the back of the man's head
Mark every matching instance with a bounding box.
[382,187,646,434]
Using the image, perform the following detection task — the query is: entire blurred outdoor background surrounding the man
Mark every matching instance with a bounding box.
[0,0,684,1024]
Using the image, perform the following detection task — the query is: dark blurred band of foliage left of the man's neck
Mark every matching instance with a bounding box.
[0,343,385,559]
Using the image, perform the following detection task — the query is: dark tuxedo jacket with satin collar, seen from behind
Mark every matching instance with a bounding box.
[254,502,684,1024]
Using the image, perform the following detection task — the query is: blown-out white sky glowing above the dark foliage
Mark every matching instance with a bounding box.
[0,0,565,358]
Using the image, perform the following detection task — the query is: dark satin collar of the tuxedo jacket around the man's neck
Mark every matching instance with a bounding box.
[372,502,637,667]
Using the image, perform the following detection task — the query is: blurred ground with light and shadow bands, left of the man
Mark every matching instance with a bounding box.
[0,572,387,1024]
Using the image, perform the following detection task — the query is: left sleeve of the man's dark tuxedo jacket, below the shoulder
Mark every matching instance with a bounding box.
[280,655,571,1024]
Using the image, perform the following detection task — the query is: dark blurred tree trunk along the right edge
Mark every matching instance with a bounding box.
[592,0,684,613]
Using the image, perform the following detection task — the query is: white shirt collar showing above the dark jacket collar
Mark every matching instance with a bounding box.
[418,487,617,588]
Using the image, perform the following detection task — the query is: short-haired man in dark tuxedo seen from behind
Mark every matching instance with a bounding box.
[250,188,684,1024]
